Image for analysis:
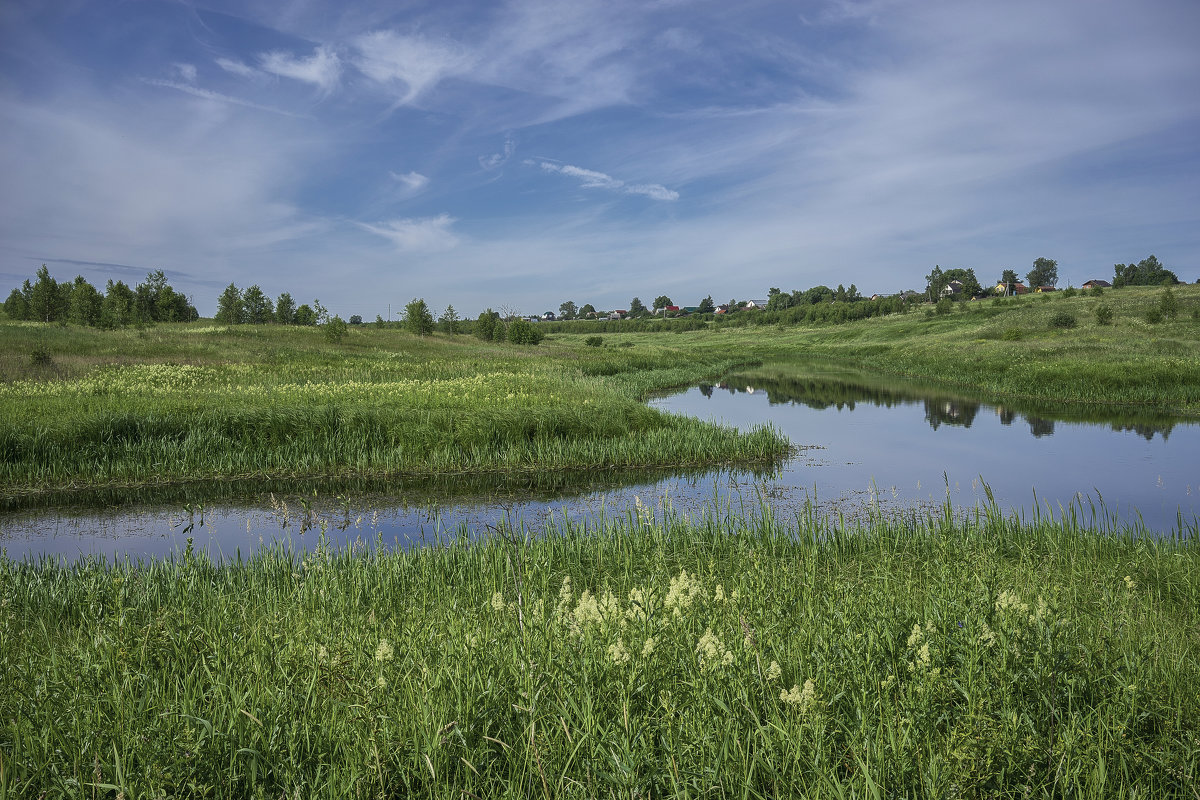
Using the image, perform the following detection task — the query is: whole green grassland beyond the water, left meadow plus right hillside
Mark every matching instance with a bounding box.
[0,285,1200,493]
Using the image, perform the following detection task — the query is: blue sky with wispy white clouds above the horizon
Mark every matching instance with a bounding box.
[0,0,1200,320]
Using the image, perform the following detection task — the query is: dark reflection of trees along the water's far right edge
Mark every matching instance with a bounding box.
[720,375,1176,440]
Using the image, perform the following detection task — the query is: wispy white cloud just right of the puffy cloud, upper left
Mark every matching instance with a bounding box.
[354,30,472,104]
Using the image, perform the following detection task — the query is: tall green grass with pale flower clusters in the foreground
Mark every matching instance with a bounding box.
[0,509,1200,798]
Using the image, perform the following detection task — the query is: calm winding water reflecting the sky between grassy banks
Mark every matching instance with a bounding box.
[0,365,1200,559]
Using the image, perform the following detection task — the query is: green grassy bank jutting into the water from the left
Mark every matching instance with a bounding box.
[0,324,787,494]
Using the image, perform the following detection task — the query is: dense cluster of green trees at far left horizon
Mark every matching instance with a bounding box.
[4,264,200,330]
